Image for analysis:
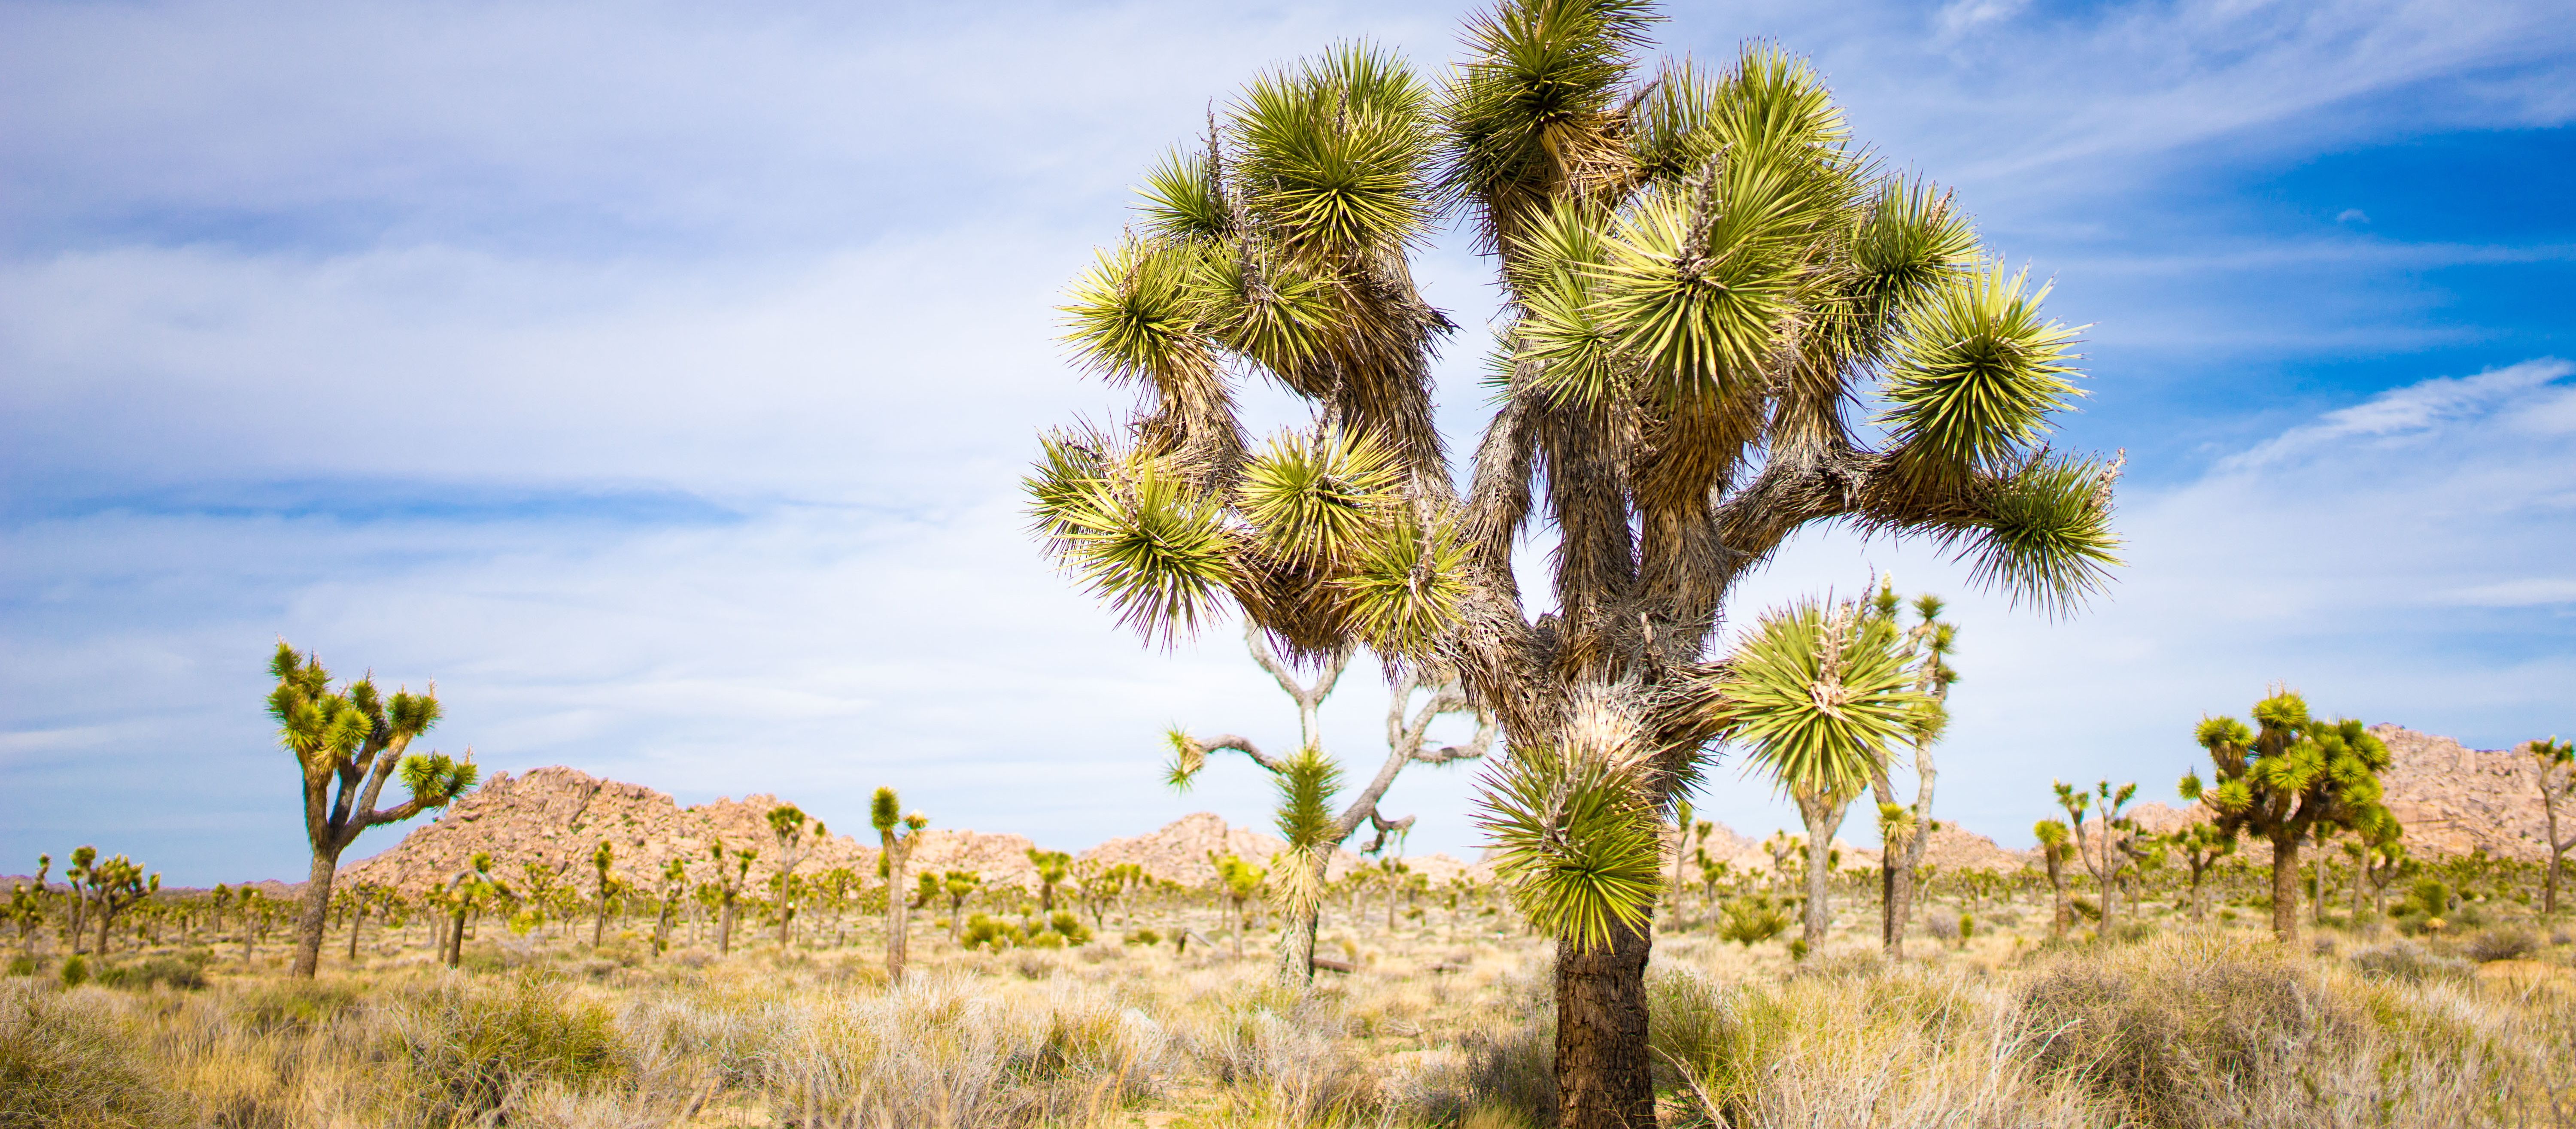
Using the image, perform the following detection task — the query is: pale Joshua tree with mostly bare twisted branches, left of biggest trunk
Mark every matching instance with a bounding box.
[1167,616,1494,987]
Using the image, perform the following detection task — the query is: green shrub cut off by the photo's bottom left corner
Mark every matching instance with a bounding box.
[0,985,191,1129]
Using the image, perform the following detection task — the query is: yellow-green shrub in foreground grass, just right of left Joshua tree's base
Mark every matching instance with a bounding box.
[394,974,626,1124]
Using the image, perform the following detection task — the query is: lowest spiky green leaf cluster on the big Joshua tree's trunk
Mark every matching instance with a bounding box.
[1476,745,1664,951]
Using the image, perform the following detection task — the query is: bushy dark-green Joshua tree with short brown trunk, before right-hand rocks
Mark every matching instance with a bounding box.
[2182,686,2388,941]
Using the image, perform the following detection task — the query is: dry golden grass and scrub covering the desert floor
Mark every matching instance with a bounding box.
[0,869,2576,1129]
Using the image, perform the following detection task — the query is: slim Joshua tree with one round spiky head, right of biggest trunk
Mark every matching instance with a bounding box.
[1718,601,1927,954]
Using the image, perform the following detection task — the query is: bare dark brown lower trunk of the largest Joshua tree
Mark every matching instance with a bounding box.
[1556,920,1654,1129]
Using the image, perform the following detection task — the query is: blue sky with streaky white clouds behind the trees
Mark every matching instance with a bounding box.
[0,0,2576,884]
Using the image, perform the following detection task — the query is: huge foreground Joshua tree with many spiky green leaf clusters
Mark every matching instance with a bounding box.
[1030,0,2115,1113]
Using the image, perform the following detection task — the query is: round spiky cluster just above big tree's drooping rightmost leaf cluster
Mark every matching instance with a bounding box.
[1883,263,2081,474]
